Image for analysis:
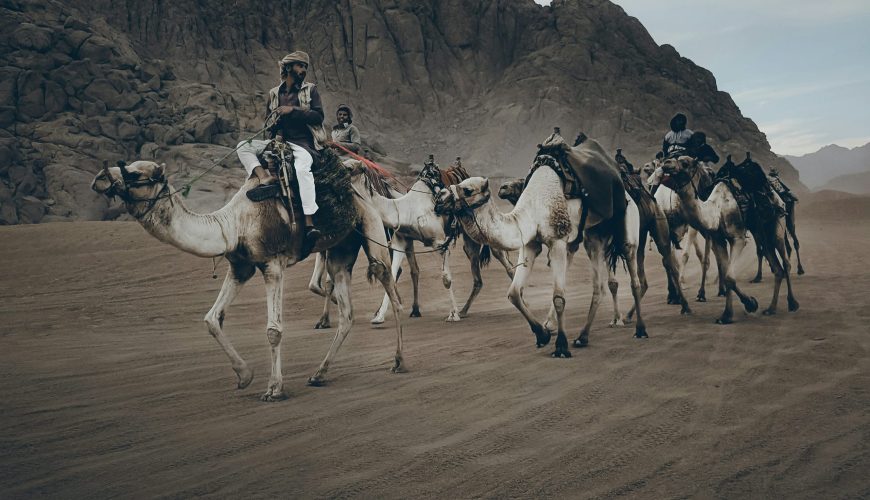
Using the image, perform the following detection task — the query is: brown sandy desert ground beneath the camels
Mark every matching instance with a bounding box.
[0,199,870,498]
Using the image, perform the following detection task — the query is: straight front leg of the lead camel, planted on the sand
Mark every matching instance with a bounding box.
[260,259,287,401]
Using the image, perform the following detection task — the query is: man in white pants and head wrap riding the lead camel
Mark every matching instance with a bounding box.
[238,51,328,248]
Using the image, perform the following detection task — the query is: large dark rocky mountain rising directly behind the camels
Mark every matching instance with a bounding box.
[0,0,802,223]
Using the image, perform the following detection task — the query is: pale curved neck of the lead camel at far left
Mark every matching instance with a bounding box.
[139,193,237,257]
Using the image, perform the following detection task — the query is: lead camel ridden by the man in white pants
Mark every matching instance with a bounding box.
[91,156,403,401]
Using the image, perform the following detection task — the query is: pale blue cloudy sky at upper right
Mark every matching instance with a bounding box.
[535,0,870,156]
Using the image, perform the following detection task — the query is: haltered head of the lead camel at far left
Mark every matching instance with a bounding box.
[91,161,169,219]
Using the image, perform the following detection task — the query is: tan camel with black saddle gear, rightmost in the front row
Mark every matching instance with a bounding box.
[662,156,799,324]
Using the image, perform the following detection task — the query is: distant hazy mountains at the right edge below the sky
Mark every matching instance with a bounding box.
[784,143,870,189]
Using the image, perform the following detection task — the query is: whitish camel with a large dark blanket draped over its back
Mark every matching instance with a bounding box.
[439,144,647,358]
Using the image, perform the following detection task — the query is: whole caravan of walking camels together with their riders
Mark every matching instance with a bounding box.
[92,52,803,401]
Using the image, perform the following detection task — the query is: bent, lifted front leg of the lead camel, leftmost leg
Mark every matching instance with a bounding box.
[203,262,256,389]
